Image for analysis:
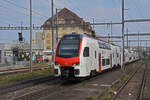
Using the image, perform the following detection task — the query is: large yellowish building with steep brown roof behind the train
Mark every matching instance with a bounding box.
[42,8,92,50]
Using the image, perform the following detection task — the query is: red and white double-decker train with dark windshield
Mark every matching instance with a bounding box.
[55,33,138,79]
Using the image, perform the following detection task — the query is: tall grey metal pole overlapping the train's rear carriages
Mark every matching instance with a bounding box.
[121,0,124,71]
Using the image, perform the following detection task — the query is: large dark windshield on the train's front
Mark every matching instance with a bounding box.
[56,35,81,58]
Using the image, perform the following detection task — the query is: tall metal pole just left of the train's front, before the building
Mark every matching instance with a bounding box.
[51,0,55,67]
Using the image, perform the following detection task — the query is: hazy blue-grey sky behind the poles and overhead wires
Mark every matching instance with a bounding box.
[0,0,150,45]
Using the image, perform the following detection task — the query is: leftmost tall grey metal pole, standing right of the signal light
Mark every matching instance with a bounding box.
[30,0,32,73]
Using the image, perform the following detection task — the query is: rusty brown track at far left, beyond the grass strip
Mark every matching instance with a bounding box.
[0,66,49,76]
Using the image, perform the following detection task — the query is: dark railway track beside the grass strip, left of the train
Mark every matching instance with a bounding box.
[0,75,58,100]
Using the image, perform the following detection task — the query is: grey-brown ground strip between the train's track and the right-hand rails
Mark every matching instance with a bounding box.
[42,63,141,100]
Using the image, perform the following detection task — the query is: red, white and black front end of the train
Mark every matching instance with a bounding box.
[54,34,82,79]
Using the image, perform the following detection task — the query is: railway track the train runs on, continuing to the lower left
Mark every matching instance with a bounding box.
[0,66,122,100]
